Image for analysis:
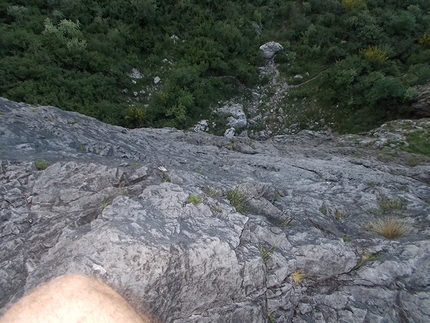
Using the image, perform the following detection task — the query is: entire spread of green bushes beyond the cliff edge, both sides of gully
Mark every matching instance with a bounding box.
[0,0,430,132]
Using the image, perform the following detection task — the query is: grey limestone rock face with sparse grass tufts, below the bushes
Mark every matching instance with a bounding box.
[0,99,430,323]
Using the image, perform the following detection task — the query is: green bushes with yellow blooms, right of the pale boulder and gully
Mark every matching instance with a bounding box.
[276,0,430,133]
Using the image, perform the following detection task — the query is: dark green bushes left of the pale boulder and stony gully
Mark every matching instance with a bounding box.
[0,0,272,128]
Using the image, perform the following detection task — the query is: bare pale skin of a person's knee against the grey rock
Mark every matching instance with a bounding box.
[0,275,152,323]
